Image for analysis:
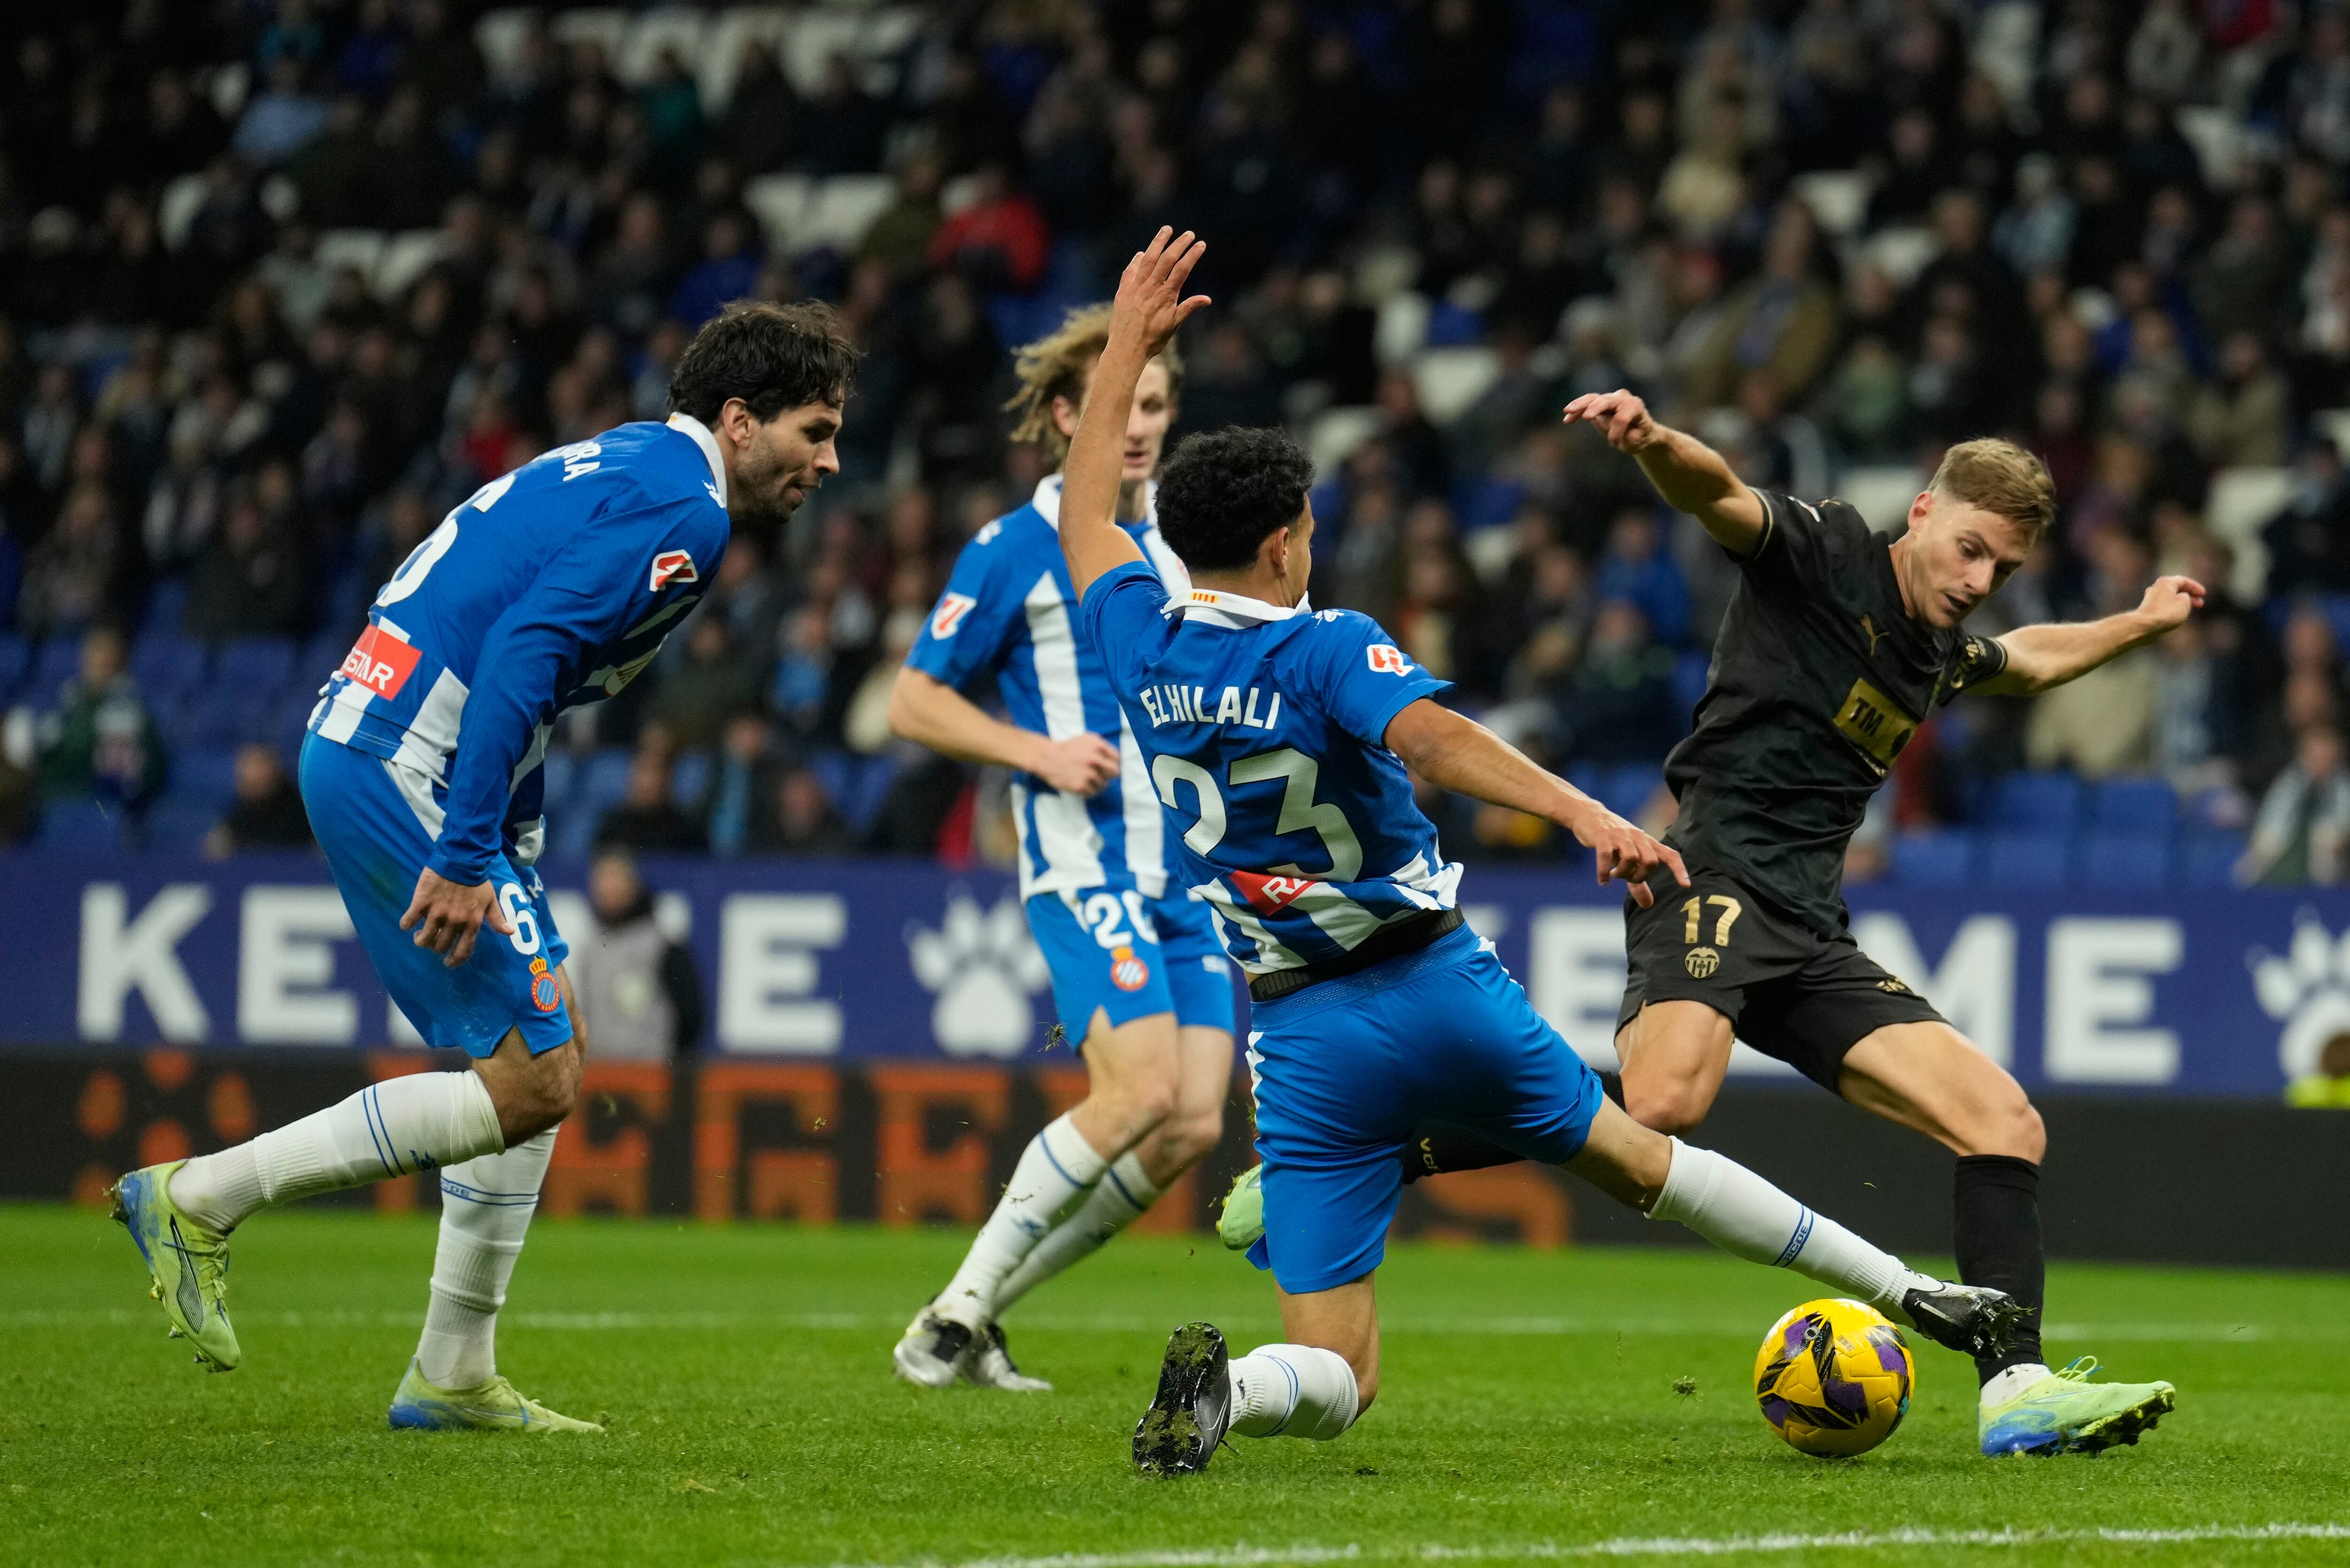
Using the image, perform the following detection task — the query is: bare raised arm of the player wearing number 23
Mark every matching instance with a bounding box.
[1060,228,1208,599]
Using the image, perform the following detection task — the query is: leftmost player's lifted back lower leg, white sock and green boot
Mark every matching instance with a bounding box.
[113,1072,505,1373]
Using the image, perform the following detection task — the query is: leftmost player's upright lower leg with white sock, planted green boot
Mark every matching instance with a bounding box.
[390,1129,602,1432]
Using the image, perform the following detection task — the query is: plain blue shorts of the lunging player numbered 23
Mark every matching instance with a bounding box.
[1248,926,1603,1295]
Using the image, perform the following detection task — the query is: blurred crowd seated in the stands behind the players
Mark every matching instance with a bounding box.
[0,0,2350,882]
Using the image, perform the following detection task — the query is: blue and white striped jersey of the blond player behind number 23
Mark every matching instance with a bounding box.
[905,475,1191,898]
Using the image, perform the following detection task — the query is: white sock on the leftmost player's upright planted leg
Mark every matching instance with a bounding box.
[416,1126,555,1389]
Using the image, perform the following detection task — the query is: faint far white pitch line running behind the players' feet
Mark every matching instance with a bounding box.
[0,1307,2312,1345]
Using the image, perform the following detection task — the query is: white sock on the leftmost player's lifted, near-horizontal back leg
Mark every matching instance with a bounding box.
[172,1072,505,1230]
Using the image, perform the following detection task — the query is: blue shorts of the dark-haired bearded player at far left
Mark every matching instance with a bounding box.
[301,736,571,1056]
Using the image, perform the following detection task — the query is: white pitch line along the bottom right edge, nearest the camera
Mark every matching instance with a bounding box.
[839,1523,2350,1568]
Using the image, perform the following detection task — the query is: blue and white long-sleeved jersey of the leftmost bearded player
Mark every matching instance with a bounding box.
[310,414,731,886]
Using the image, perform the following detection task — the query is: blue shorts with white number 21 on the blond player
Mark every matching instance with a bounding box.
[1027,886,1234,1049]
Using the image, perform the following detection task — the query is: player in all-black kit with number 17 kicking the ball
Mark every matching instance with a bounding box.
[1224,392,2204,1455]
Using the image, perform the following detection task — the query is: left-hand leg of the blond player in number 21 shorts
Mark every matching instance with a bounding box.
[891,1011,1180,1389]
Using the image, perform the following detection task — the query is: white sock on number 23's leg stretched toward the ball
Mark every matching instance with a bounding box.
[1647,1138,1941,1321]
